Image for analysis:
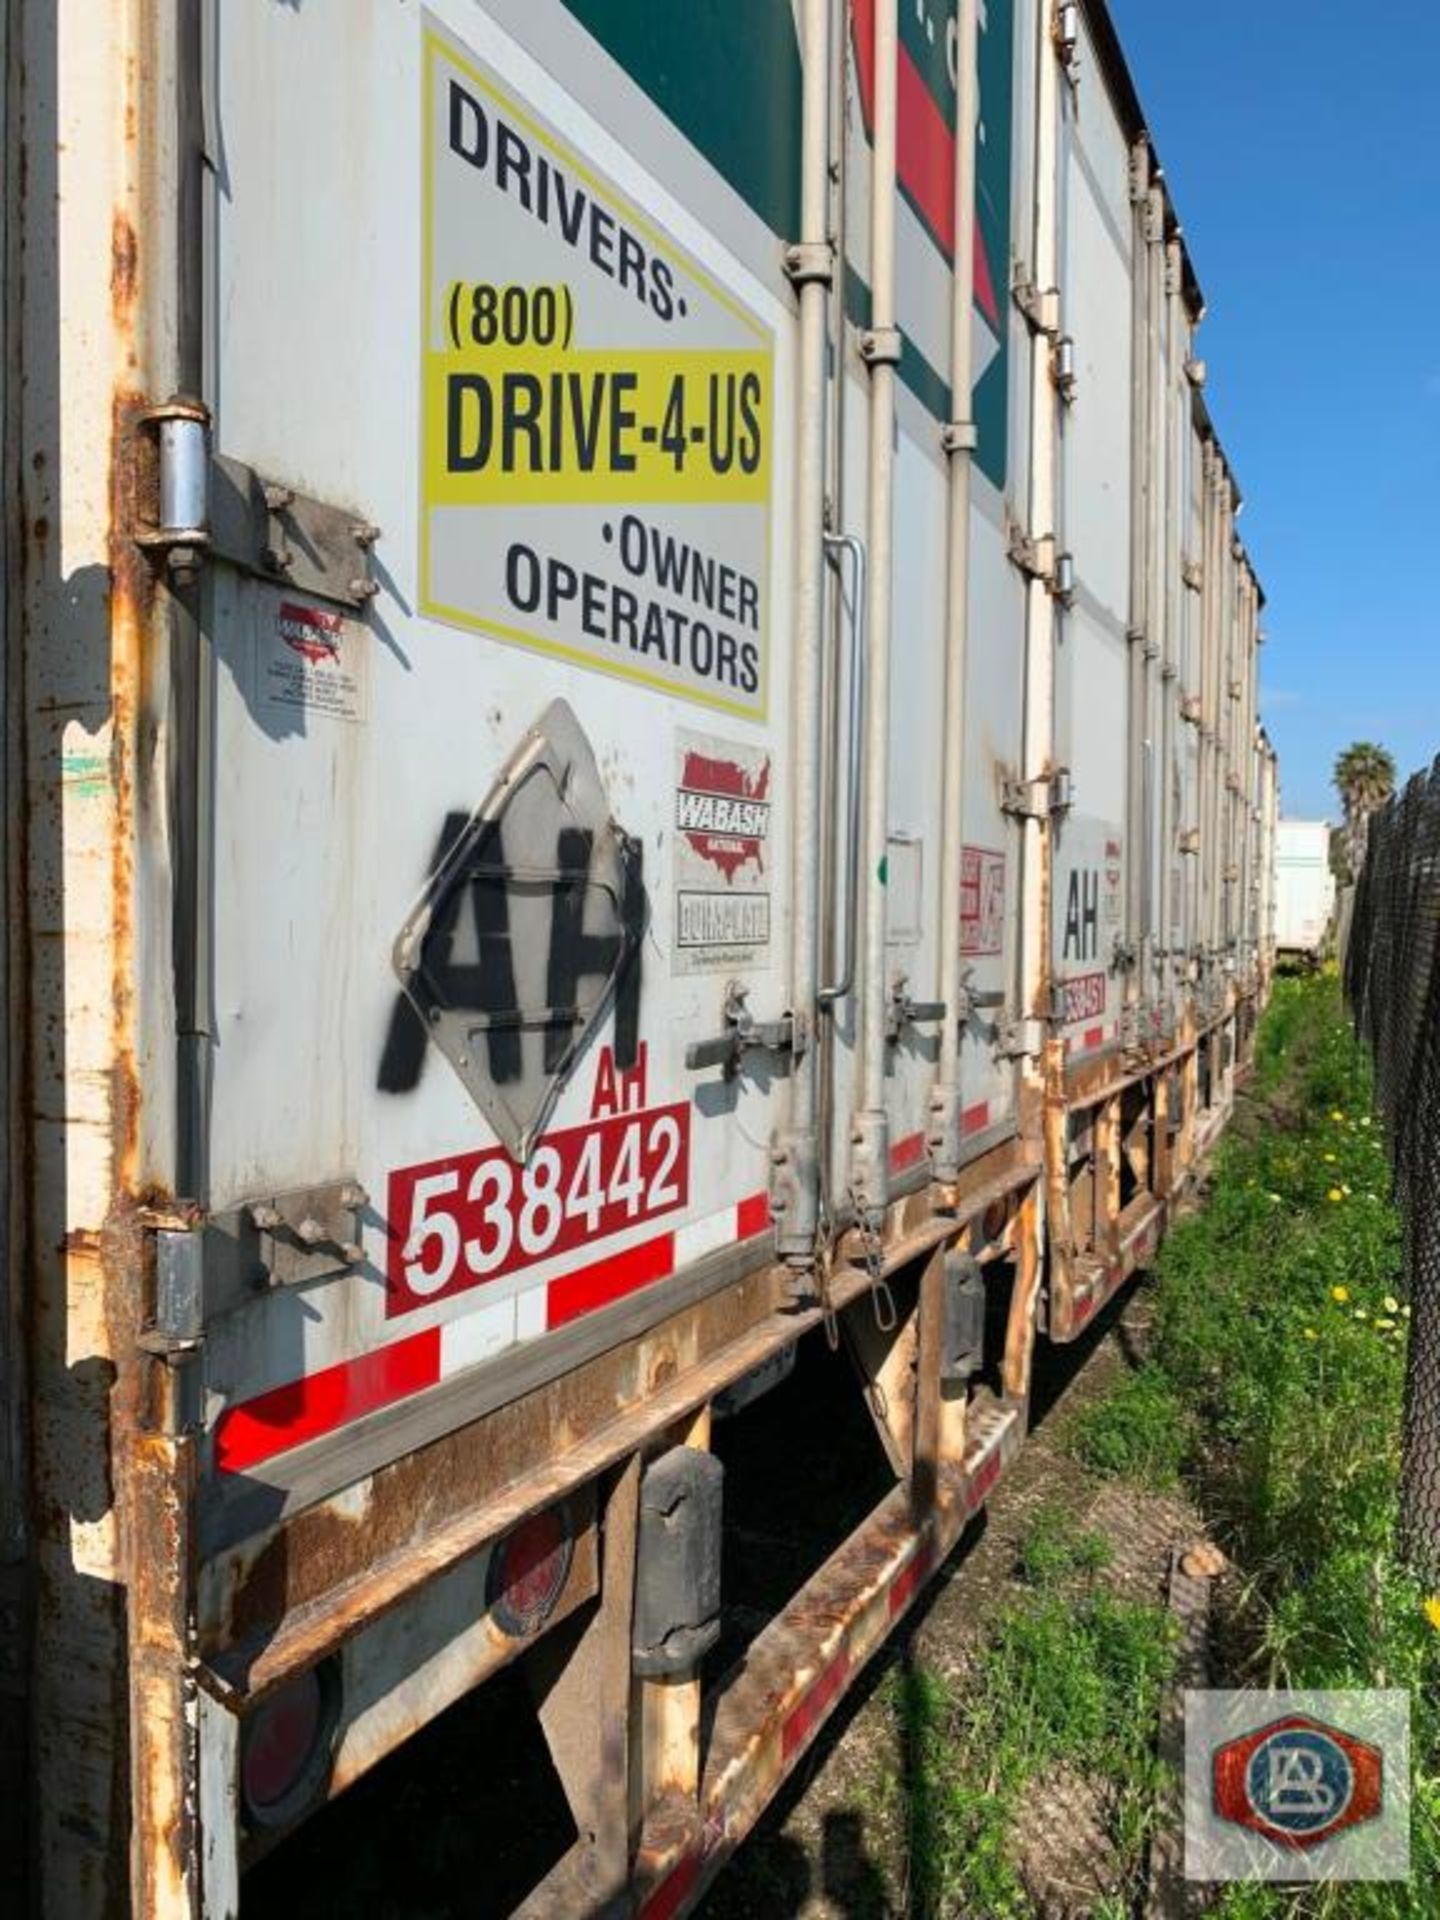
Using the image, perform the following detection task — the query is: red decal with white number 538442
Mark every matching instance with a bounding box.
[386,1104,689,1319]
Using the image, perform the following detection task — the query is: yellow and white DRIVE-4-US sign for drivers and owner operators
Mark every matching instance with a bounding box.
[420,25,774,716]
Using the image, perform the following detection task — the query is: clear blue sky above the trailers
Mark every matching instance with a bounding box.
[1110,0,1440,818]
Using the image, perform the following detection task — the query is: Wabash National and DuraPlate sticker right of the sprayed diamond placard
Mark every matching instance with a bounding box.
[672,733,774,973]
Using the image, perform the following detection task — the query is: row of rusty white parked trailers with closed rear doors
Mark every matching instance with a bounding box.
[0,0,1275,1920]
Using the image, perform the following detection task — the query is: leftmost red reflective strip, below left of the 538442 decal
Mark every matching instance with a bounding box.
[215,1327,440,1473]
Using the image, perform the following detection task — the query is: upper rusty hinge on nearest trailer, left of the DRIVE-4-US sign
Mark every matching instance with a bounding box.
[131,397,380,609]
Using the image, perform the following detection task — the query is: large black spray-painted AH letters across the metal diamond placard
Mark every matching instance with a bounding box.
[376,812,645,1092]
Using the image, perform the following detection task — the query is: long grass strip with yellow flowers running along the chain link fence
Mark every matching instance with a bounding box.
[1073,975,1440,1920]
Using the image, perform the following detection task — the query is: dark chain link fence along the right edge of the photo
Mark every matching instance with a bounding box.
[1344,760,1440,1578]
